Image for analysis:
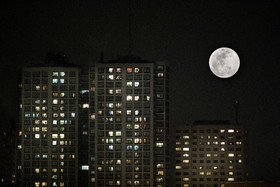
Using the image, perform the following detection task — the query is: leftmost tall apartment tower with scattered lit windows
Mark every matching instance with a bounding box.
[17,55,79,186]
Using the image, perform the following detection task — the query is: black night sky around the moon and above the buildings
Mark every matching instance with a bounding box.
[0,0,280,180]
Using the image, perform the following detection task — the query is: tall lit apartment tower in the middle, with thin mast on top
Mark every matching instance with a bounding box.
[80,57,169,187]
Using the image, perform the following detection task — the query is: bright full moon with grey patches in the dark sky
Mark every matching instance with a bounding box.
[209,47,240,78]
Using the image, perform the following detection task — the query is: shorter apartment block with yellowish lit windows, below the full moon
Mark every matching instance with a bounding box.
[175,121,247,187]
